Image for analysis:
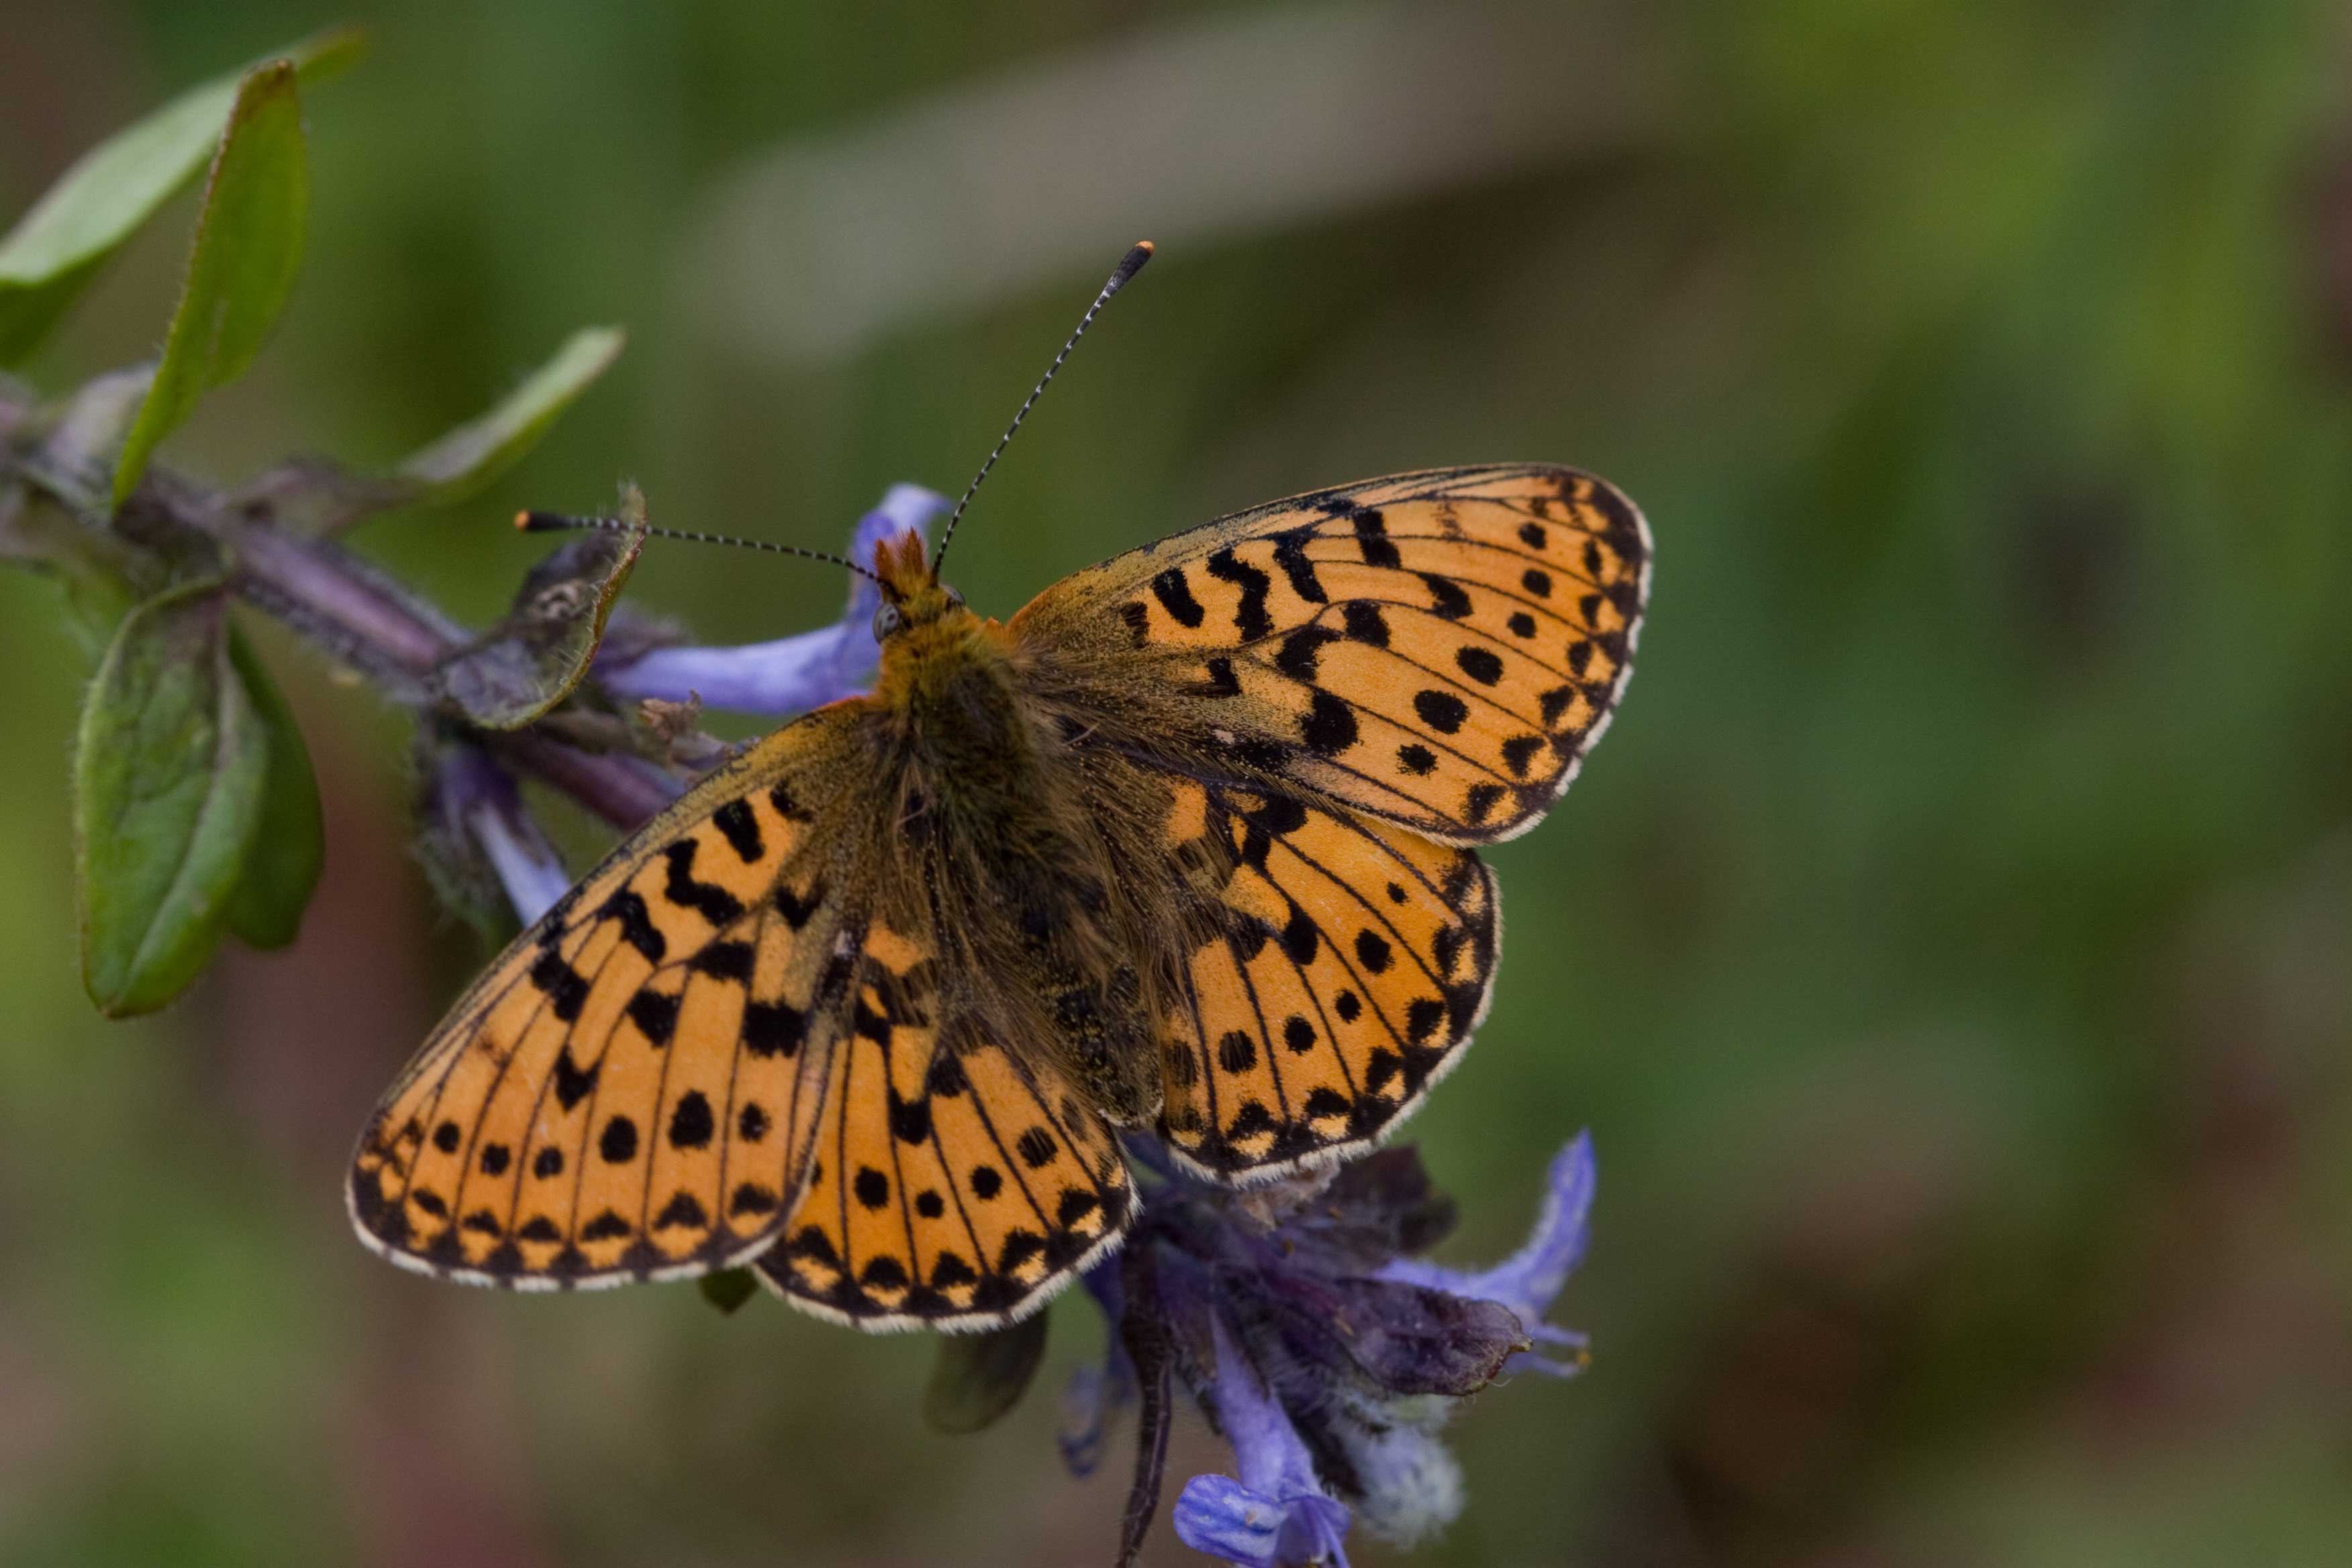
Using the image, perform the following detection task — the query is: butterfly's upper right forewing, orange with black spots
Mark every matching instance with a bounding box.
[1014,465,1649,844]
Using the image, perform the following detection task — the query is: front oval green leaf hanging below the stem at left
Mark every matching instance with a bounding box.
[73,583,271,1018]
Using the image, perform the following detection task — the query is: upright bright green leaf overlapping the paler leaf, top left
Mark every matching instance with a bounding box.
[115,59,311,505]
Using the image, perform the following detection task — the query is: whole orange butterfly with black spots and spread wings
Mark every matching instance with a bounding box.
[348,254,1651,1328]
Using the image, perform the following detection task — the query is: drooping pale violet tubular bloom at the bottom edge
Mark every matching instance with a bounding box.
[1176,1316,1348,1568]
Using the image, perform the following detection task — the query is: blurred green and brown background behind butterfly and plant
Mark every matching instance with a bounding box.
[0,0,2352,1568]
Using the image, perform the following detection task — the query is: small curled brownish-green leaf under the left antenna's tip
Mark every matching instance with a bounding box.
[433,489,644,729]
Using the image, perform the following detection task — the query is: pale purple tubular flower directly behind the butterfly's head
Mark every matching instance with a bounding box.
[597,484,948,715]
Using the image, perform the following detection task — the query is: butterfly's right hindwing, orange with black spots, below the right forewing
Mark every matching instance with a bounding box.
[1159,783,1498,1180]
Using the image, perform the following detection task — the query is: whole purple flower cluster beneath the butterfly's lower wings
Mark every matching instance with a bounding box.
[1065,1136,1592,1568]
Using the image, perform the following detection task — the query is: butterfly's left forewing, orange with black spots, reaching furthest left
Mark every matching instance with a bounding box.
[348,715,856,1286]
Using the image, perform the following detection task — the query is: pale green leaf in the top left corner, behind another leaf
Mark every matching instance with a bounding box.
[0,28,362,364]
